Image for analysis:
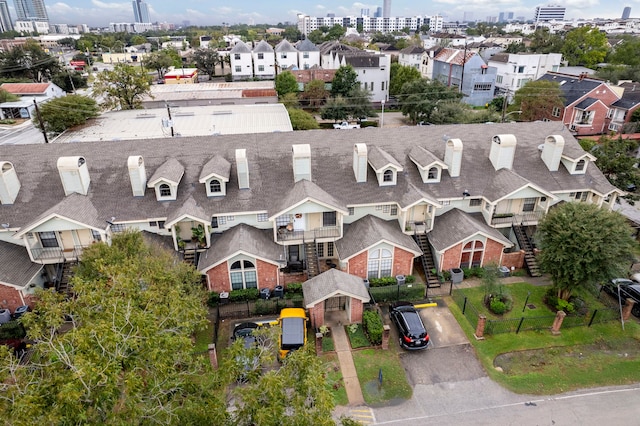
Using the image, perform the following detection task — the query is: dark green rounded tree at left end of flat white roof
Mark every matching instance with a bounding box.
[33,95,99,133]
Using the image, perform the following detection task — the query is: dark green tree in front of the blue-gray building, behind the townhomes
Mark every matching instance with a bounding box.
[398,78,463,124]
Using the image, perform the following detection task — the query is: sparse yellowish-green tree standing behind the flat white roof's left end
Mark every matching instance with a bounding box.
[93,64,151,109]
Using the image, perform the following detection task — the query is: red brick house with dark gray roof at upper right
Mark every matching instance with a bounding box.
[540,73,621,136]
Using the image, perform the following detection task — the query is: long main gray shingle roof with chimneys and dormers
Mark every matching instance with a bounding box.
[0,122,615,236]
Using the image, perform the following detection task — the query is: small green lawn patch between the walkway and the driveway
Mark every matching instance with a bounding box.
[352,349,412,405]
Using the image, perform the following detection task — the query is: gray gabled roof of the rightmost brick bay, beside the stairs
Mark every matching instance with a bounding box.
[429,209,513,251]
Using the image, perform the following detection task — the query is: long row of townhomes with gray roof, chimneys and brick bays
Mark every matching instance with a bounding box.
[0,122,620,310]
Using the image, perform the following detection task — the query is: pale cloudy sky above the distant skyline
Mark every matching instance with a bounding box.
[3,0,634,27]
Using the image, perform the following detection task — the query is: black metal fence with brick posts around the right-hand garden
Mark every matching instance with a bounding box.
[452,289,620,334]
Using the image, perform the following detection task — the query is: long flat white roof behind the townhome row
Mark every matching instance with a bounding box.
[55,104,293,143]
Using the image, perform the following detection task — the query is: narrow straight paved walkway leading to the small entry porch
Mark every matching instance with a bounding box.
[326,312,364,406]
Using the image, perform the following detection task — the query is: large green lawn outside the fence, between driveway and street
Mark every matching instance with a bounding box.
[447,298,640,395]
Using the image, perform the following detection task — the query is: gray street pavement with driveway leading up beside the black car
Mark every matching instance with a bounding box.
[372,302,640,426]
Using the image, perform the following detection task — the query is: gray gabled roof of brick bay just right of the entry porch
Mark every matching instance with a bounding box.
[335,215,422,260]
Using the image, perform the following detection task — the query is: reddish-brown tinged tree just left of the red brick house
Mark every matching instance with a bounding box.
[509,80,564,121]
